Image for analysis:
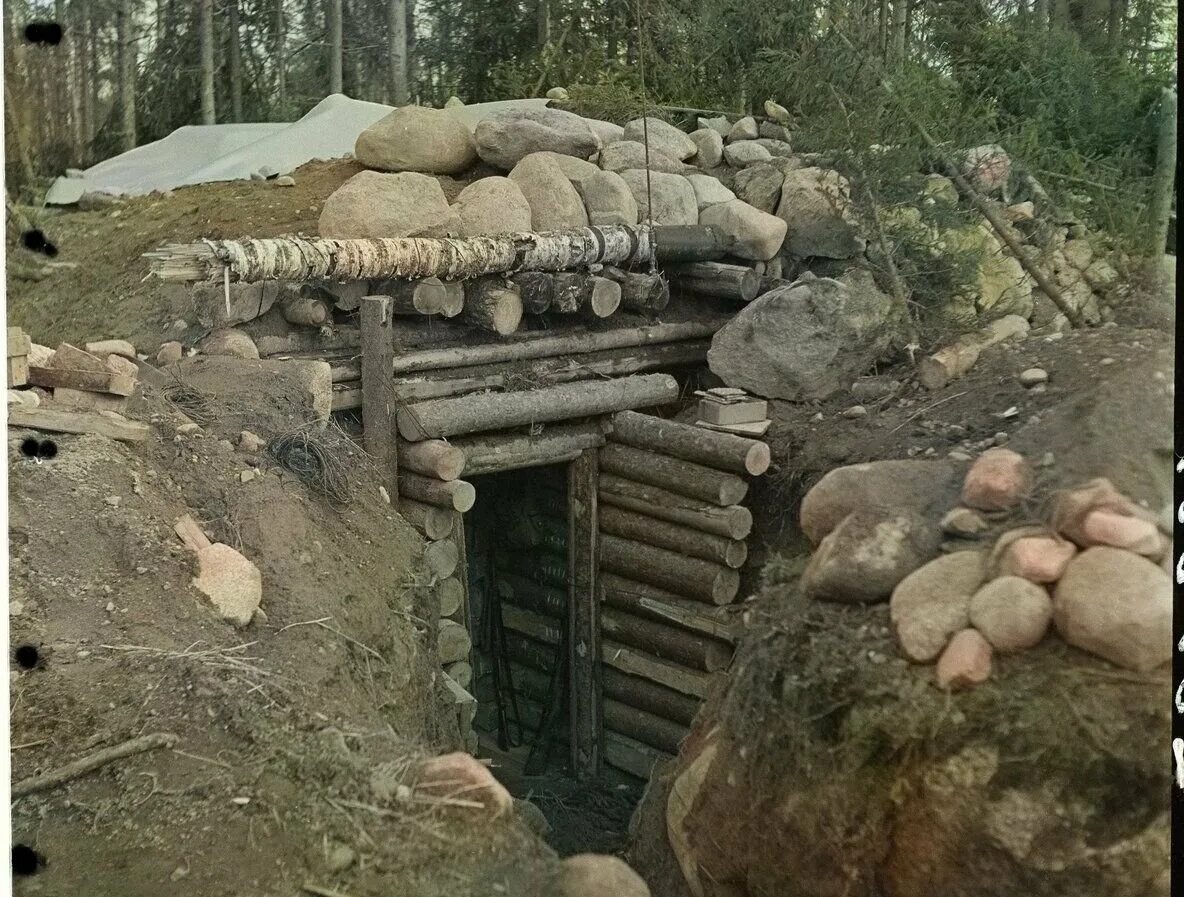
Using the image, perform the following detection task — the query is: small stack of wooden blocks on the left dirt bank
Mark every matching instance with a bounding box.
[28,340,140,414]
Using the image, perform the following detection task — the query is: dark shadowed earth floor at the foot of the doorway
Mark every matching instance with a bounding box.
[481,733,645,857]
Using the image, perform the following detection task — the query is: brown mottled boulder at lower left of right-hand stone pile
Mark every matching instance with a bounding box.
[802,509,941,604]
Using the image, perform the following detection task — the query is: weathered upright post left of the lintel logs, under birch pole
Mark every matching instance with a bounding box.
[361,296,399,508]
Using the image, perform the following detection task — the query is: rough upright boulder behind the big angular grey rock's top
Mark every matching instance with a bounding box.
[781,168,867,258]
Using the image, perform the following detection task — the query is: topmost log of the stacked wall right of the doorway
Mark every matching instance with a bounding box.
[611,411,771,477]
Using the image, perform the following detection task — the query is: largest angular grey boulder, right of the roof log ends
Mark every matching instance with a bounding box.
[707,267,906,401]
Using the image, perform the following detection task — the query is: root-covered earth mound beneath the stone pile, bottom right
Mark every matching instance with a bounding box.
[630,582,1169,897]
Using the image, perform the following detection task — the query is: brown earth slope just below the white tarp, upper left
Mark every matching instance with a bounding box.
[8,160,476,351]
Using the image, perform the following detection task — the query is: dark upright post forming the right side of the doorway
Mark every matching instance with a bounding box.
[567,449,601,779]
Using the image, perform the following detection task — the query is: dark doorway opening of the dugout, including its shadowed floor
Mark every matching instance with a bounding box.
[465,464,644,856]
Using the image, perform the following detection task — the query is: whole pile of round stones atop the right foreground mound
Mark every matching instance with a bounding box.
[802,447,1172,689]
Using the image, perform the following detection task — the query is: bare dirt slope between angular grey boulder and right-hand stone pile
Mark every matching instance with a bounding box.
[755,327,1175,563]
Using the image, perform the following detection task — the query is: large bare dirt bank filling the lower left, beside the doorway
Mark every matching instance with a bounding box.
[9,389,554,896]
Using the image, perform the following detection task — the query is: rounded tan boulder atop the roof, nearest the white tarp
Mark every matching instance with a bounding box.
[354,105,477,174]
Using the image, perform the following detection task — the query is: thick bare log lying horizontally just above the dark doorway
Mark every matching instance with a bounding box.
[398,374,678,441]
